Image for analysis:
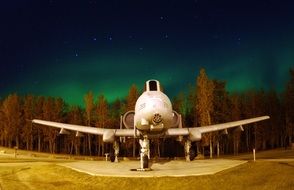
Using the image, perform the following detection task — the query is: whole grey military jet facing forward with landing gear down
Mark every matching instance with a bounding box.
[32,80,269,171]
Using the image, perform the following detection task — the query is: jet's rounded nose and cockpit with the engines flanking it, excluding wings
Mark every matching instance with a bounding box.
[121,80,182,134]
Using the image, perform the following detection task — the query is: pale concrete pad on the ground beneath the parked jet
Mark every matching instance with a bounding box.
[58,159,247,177]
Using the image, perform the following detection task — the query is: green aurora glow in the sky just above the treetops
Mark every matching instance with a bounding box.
[4,43,294,105]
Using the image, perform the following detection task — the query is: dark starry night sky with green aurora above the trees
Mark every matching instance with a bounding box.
[0,0,294,105]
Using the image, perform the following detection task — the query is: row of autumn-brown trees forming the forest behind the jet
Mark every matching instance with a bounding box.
[0,69,294,157]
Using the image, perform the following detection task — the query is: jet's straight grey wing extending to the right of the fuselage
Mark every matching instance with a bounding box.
[166,116,270,141]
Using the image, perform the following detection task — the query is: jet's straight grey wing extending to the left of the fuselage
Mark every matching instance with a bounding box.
[32,119,134,142]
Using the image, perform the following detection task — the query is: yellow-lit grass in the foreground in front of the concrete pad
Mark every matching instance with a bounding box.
[0,161,294,190]
